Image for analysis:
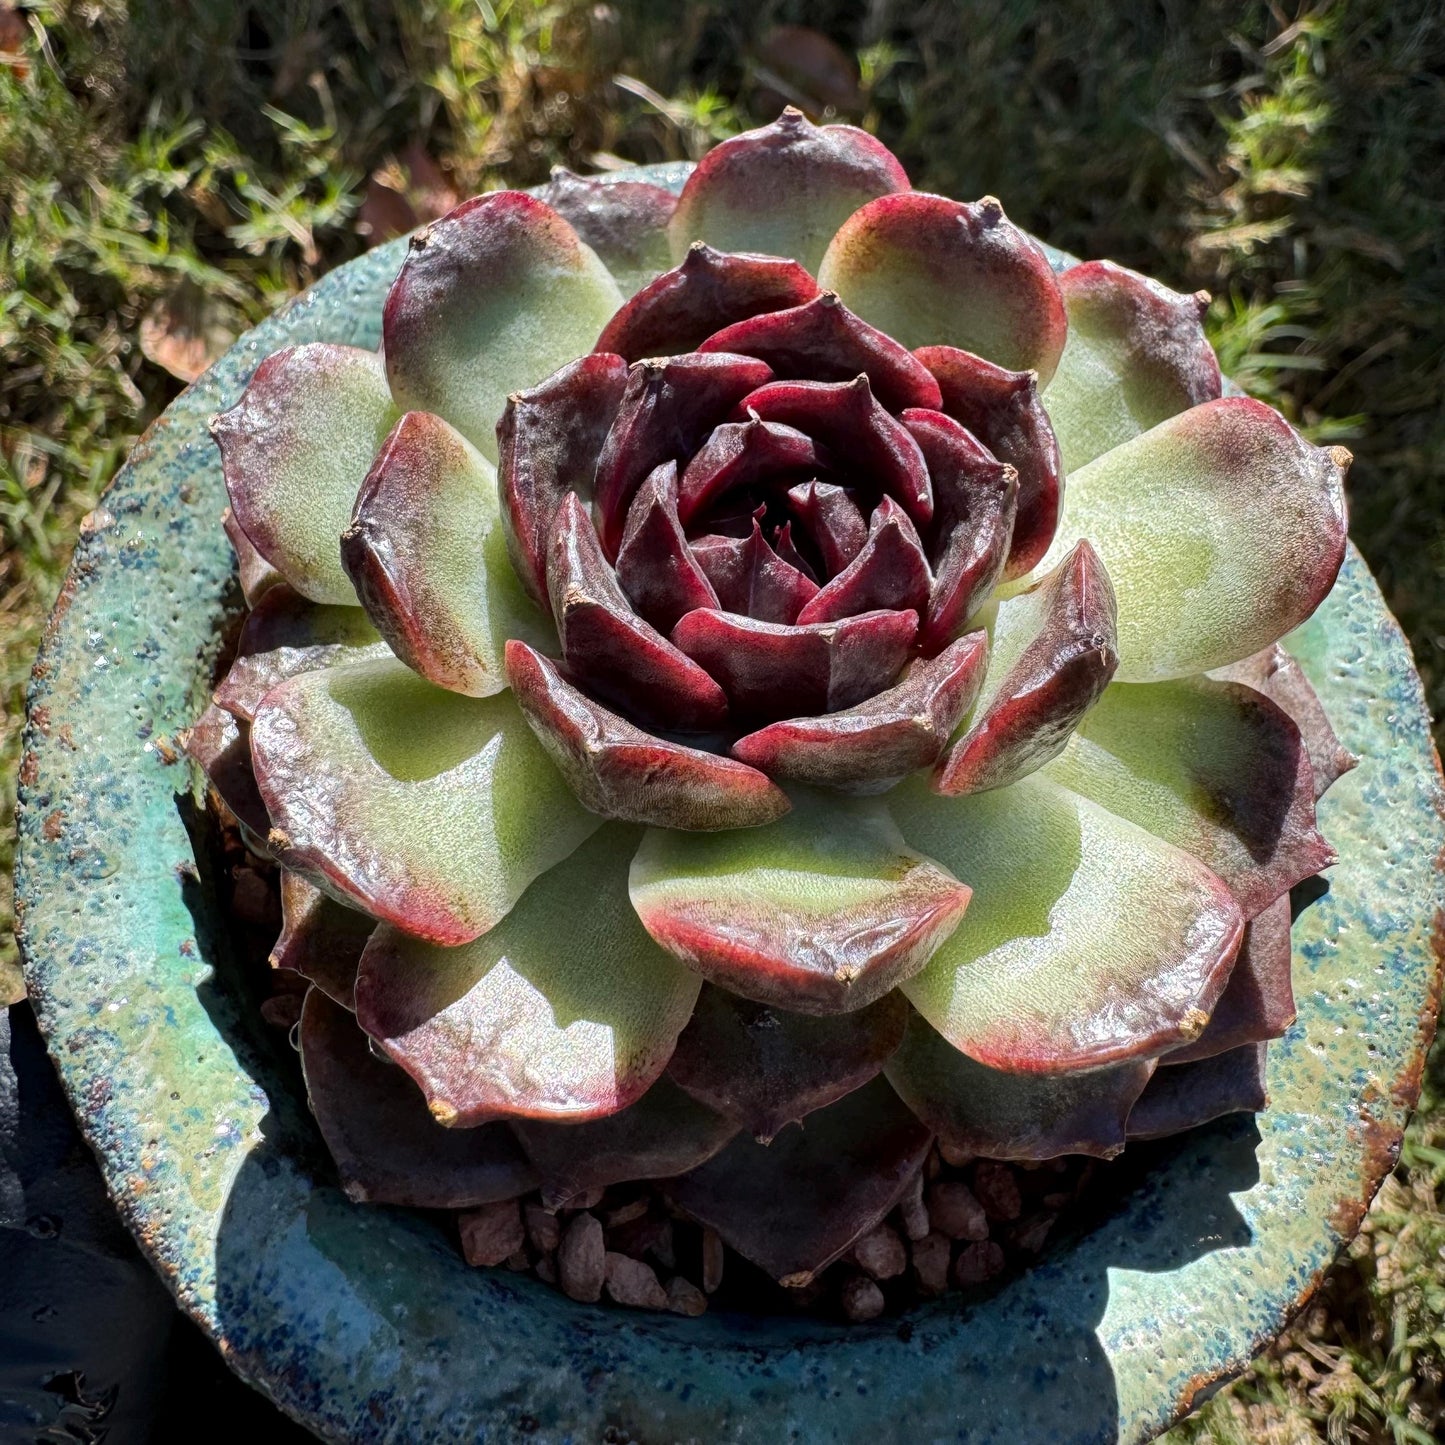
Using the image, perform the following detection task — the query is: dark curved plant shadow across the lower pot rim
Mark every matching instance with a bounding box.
[181,798,1259,1445]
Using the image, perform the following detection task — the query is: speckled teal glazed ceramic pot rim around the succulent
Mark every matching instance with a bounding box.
[16,168,1445,1445]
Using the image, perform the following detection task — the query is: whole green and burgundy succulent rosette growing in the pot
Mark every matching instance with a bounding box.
[192,111,1350,1282]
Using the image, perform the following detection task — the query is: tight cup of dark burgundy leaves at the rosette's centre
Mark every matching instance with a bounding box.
[500,262,1046,750]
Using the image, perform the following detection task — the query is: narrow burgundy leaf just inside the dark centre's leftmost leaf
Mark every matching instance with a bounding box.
[597,351,773,558]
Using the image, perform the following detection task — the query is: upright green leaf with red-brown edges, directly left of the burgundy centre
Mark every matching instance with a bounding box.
[341,412,551,698]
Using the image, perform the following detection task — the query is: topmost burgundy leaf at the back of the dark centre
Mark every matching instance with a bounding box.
[597,241,818,361]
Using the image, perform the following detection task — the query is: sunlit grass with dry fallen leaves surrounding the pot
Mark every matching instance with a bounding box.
[0,0,1445,1445]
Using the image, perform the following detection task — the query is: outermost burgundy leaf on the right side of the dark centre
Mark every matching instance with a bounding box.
[915,347,1064,577]
